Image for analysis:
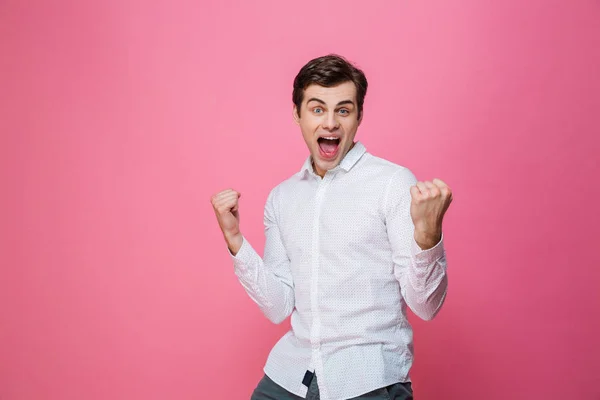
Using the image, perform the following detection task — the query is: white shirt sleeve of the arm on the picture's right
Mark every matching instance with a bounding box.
[384,168,448,320]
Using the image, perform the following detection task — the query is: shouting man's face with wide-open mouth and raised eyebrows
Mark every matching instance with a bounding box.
[294,82,362,178]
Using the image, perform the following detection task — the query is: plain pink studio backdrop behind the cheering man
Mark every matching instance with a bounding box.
[0,0,600,400]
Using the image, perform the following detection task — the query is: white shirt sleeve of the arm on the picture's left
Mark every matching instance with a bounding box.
[229,187,294,324]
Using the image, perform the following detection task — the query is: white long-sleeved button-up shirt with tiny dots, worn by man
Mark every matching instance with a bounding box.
[232,142,447,400]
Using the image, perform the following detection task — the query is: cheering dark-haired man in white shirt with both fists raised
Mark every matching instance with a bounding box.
[212,55,452,400]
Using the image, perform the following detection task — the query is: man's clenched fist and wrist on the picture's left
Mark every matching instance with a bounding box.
[211,189,242,255]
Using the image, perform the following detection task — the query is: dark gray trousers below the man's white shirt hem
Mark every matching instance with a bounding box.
[250,375,413,400]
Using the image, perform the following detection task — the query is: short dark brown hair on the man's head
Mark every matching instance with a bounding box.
[292,54,367,119]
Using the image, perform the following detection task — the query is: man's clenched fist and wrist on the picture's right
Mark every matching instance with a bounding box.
[410,179,452,250]
